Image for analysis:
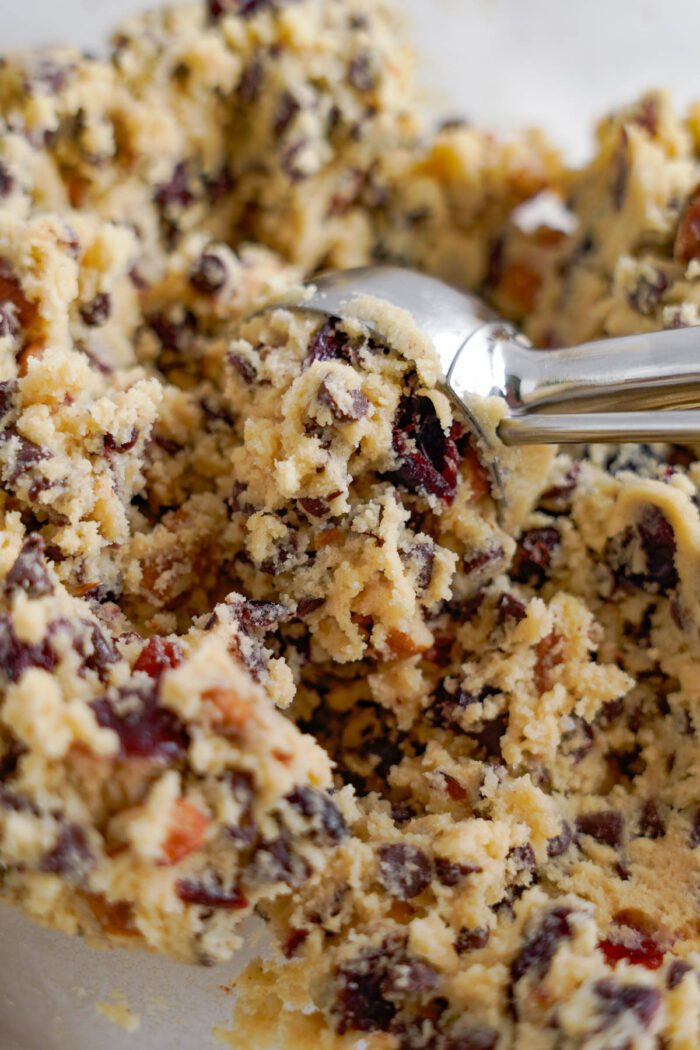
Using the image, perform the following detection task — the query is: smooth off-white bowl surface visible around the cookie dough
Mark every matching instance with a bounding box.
[0,0,700,1050]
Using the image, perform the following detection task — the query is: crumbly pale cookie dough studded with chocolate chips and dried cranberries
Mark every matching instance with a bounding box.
[0,0,700,1050]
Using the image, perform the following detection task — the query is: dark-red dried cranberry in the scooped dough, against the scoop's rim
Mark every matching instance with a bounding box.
[386,395,461,503]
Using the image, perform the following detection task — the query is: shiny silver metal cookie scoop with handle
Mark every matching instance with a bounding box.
[270,267,700,492]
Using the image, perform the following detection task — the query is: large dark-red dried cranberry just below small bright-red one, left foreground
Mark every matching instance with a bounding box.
[90,686,189,762]
